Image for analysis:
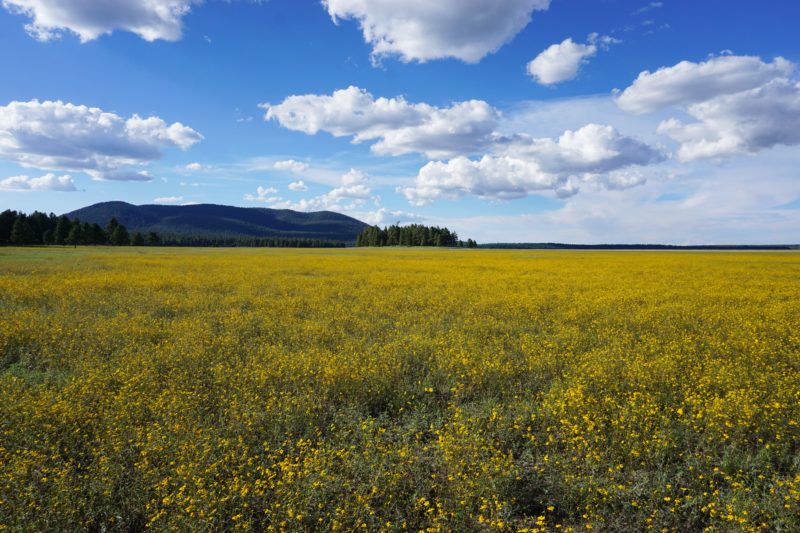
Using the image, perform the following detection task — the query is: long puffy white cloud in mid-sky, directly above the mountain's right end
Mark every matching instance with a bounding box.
[261,86,500,158]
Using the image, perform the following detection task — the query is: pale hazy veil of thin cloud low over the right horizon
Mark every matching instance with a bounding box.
[440,147,800,245]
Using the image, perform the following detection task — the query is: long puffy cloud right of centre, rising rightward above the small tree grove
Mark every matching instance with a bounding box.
[398,124,663,205]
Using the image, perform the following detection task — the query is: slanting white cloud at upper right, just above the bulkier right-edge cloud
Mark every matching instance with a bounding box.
[617,56,794,113]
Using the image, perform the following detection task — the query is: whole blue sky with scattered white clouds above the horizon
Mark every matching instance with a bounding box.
[0,0,800,244]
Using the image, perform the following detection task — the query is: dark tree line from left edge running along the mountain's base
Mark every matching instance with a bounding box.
[0,209,345,248]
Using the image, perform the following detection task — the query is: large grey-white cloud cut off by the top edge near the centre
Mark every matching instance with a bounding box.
[323,0,550,63]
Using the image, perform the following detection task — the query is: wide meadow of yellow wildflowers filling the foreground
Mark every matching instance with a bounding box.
[0,248,800,531]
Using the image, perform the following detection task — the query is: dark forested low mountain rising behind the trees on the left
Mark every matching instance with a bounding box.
[66,202,367,242]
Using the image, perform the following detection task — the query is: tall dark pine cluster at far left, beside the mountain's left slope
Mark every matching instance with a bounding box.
[0,209,153,246]
